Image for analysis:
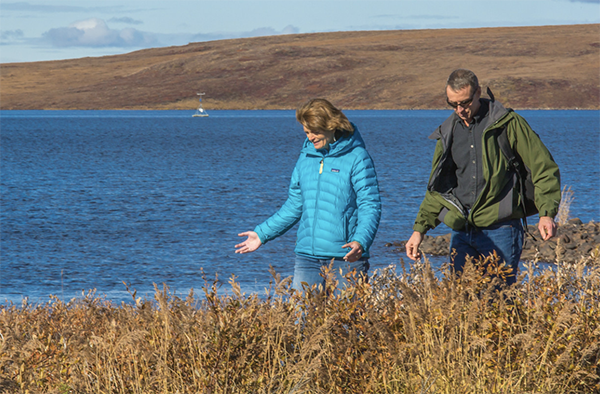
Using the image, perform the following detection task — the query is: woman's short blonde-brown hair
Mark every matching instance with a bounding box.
[296,99,354,134]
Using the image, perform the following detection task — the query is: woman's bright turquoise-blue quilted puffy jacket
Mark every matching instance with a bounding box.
[254,126,381,258]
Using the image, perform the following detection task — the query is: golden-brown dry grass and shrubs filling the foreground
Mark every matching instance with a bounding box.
[0,260,600,394]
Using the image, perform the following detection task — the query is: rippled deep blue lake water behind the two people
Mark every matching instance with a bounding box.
[0,111,600,303]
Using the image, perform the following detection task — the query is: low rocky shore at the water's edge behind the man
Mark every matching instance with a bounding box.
[386,218,600,263]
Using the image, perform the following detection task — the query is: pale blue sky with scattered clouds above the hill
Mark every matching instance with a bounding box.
[0,0,600,63]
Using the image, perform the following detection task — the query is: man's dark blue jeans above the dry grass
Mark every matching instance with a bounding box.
[450,219,523,285]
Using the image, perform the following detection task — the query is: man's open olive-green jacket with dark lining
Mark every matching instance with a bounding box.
[413,100,561,233]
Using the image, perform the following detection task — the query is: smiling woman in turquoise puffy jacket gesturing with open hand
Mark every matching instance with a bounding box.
[235,99,381,290]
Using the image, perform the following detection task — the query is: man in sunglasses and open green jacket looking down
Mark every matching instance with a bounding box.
[406,69,561,284]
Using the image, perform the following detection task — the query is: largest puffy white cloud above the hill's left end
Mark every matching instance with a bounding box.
[43,18,156,48]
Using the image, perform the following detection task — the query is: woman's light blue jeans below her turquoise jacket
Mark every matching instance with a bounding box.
[292,254,369,291]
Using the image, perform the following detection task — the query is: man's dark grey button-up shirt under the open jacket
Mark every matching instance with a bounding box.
[451,100,489,210]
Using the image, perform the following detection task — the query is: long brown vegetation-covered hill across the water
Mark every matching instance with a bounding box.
[0,24,600,109]
